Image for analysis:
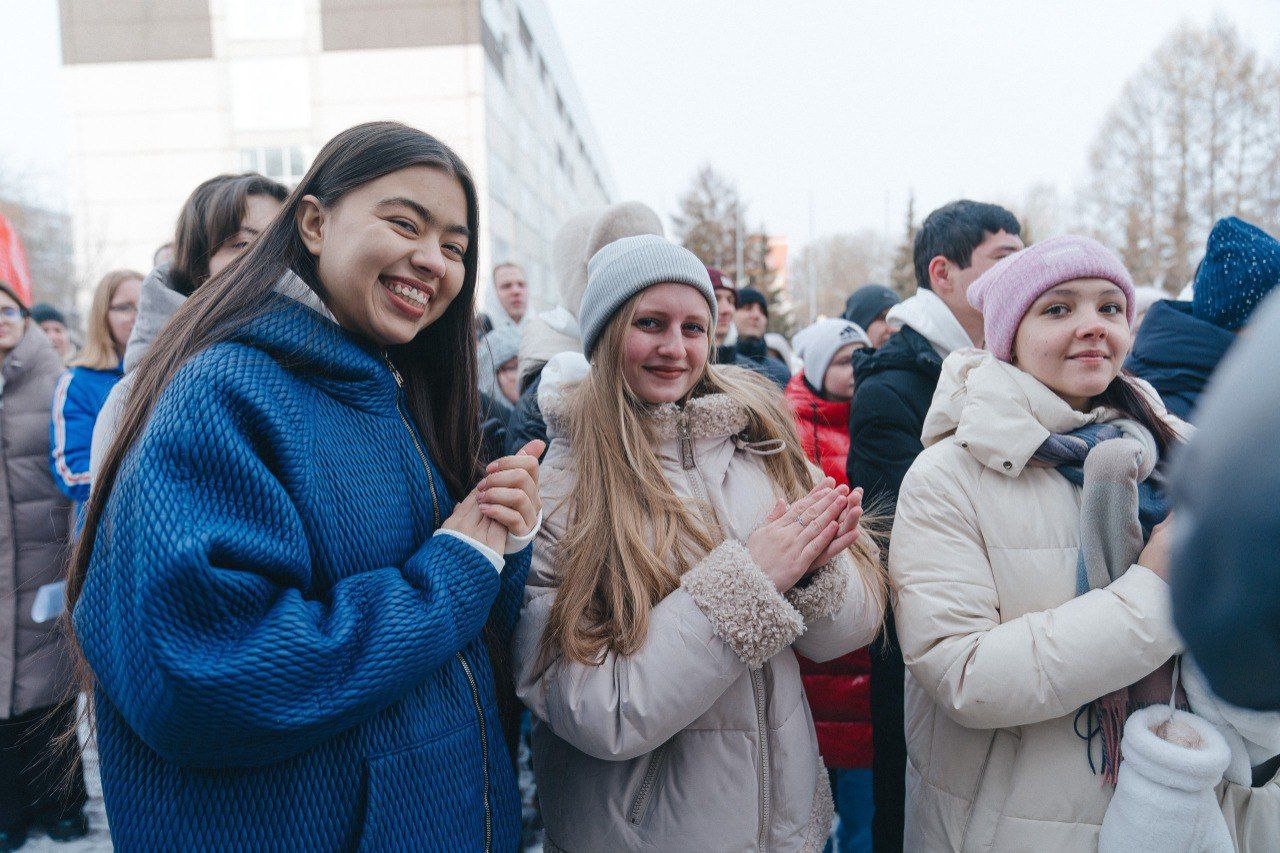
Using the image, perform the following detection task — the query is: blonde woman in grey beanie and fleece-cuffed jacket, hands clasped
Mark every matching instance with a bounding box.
[515,236,884,850]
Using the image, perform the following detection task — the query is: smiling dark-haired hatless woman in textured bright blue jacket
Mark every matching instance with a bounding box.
[68,123,541,850]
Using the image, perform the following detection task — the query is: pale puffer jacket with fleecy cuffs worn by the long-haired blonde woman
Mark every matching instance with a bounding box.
[515,394,883,852]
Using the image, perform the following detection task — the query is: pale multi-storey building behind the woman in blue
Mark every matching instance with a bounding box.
[60,0,613,305]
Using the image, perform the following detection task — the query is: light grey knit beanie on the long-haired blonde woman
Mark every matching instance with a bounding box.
[577,234,716,359]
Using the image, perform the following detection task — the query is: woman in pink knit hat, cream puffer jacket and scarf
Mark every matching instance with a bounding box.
[890,237,1223,850]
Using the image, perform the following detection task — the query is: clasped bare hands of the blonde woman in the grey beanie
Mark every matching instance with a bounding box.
[746,476,863,593]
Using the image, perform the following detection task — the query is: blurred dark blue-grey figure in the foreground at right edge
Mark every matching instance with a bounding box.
[1170,289,1280,711]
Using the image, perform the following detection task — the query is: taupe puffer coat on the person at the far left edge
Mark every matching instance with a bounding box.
[0,321,72,720]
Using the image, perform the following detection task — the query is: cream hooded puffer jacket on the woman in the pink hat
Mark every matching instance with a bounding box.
[890,350,1189,850]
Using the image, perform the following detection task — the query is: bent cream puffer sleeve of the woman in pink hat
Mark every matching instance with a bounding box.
[890,455,1179,729]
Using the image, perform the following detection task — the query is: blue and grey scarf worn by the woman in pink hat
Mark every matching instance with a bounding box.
[1032,424,1187,785]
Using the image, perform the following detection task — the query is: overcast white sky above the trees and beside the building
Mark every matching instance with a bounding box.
[0,0,1280,245]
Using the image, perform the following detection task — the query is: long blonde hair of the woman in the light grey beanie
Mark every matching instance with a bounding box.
[540,296,877,666]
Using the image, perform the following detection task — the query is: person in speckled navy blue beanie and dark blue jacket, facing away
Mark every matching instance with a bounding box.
[1125,216,1280,419]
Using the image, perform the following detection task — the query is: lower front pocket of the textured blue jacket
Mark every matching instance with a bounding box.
[360,724,484,850]
